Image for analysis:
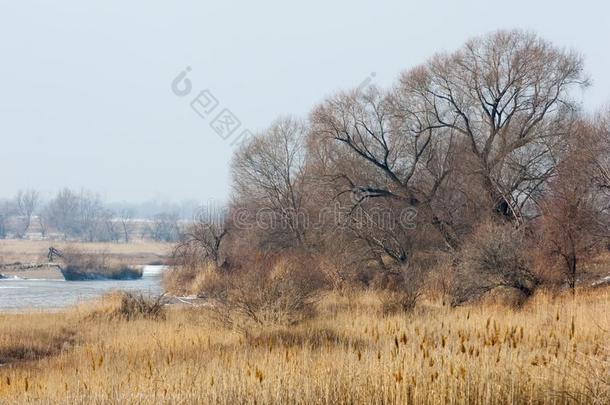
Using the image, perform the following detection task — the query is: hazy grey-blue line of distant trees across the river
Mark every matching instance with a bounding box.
[0,188,211,242]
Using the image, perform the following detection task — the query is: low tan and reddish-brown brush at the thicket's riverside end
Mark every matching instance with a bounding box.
[165,256,326,328]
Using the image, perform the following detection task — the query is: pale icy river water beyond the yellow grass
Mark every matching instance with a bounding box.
[0,266,165,312]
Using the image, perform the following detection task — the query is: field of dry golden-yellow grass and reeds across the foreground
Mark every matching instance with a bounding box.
[0,290,610,404]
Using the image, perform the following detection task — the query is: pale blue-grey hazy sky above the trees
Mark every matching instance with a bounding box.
[0,0,610,202]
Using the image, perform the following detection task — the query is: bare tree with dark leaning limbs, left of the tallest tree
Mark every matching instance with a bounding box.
[310,87,456,265]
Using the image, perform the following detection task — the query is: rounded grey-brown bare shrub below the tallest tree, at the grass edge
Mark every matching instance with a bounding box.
[452,223,538,306]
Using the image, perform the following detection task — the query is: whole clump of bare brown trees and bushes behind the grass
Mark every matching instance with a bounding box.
[167,31,610,323]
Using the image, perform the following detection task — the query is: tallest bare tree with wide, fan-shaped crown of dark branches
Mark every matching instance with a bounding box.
[401,31,587,220]
